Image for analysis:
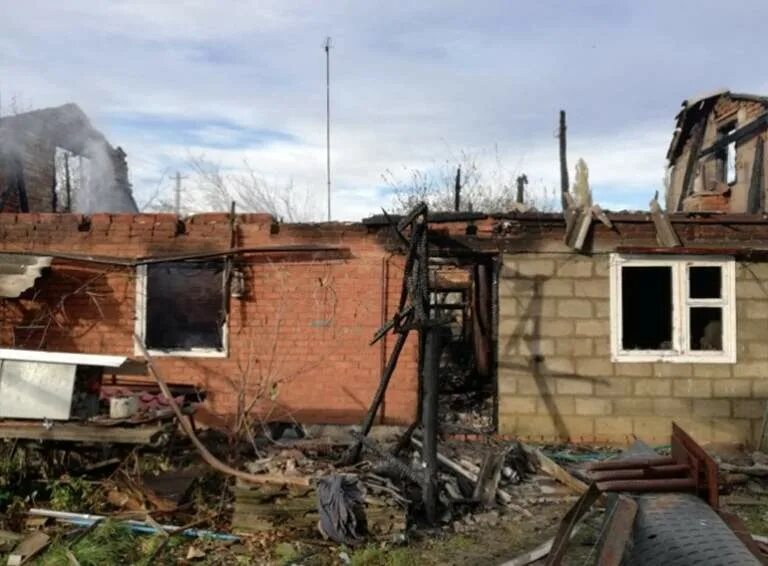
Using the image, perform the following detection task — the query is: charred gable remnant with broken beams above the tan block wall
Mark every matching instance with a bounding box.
[666,91,768,214]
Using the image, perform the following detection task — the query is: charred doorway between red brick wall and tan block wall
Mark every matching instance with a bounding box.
[429,255,499,434]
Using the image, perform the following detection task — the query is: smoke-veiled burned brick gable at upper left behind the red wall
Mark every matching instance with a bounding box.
[0,104,138,213]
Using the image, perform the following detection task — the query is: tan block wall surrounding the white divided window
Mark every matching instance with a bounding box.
[499,253,768,443]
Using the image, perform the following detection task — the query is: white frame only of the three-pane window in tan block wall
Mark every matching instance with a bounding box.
[610,254,736,364]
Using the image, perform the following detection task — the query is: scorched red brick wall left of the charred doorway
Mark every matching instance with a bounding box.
[0,214,418,424]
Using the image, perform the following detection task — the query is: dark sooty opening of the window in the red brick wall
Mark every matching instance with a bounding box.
[146,261,225,350]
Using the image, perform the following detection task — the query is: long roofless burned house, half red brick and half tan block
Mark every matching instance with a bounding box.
[0,93,768,445]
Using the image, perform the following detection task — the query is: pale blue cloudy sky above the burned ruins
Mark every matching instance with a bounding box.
[0,0,768,219]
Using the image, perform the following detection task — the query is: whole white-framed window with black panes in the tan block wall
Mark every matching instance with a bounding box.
[611,256,736,362]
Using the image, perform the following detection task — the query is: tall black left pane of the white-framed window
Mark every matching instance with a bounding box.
[621,266,672,350]
